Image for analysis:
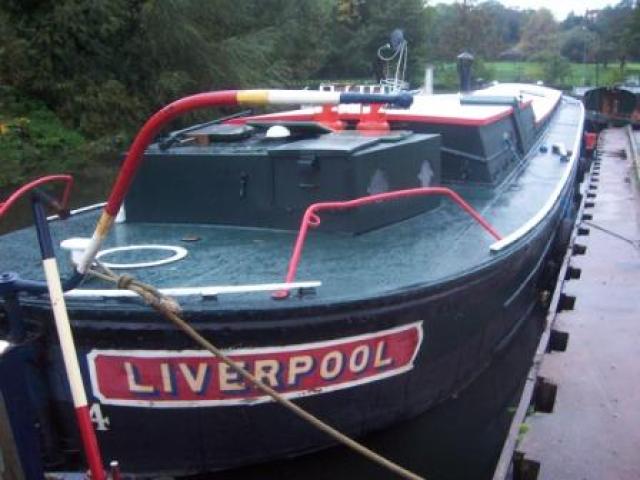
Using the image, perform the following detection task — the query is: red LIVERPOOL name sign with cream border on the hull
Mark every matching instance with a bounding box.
[87,322,422,408]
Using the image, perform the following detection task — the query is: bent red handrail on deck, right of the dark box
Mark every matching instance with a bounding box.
[273,187,502,298]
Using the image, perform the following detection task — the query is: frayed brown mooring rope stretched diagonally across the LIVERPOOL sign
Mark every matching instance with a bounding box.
[87,262,425,480]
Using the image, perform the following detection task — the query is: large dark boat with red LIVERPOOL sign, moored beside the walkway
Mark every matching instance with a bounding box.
[0,77,584,475]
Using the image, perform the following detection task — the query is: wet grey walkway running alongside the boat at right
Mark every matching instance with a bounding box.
[518,128,640,480]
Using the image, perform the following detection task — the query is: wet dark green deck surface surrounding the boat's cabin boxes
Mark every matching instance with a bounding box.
[0,99,580,309]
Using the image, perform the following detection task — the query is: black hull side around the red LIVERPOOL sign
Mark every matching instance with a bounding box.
[18,162,578,473]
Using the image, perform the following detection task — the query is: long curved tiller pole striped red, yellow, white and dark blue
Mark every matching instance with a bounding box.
[77,90,413,274]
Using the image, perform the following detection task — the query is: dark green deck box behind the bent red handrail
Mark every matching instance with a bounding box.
[125,127,440,233]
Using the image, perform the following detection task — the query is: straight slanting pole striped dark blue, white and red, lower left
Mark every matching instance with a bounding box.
[32,193,106,480]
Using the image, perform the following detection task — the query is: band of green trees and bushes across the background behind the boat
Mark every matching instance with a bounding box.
[0,0,640,188]
